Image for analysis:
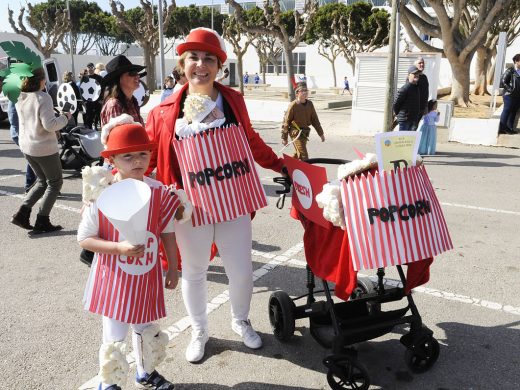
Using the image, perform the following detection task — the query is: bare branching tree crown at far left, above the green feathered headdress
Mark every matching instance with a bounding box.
[7,3,70,58]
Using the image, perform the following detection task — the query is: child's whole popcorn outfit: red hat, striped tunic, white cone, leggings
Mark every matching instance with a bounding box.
[78,115,182,390]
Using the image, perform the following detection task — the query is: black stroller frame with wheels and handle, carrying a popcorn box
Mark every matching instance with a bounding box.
[268,158,439,390]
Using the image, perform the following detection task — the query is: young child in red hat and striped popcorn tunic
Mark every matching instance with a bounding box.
[78,114,184,390]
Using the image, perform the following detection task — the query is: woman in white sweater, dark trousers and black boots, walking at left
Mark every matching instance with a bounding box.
[11,68,72,233]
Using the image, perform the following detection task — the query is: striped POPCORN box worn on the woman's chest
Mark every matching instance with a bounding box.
[173,125,267,226]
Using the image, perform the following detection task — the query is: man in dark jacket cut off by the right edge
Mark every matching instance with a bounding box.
[498,54,520,134]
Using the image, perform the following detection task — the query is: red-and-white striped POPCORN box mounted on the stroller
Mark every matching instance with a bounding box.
[341,166,453,271]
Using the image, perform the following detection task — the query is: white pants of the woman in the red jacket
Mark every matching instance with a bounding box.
[175,214,253,330]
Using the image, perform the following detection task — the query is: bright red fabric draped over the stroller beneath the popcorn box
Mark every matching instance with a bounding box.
[291,208,433,301]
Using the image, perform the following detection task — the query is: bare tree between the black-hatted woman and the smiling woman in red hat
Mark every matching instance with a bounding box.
[110,0,176,91]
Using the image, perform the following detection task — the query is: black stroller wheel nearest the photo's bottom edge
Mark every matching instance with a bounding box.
[327,356,370,390]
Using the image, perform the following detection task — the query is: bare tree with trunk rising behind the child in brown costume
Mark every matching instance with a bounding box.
[226,0,318,101]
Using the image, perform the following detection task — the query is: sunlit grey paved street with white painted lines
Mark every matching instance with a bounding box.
[0,110,520,390]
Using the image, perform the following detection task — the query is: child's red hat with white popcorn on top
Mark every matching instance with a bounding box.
[101,115,157,158]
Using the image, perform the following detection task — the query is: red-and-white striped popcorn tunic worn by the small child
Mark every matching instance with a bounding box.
[78,177,180,324]
